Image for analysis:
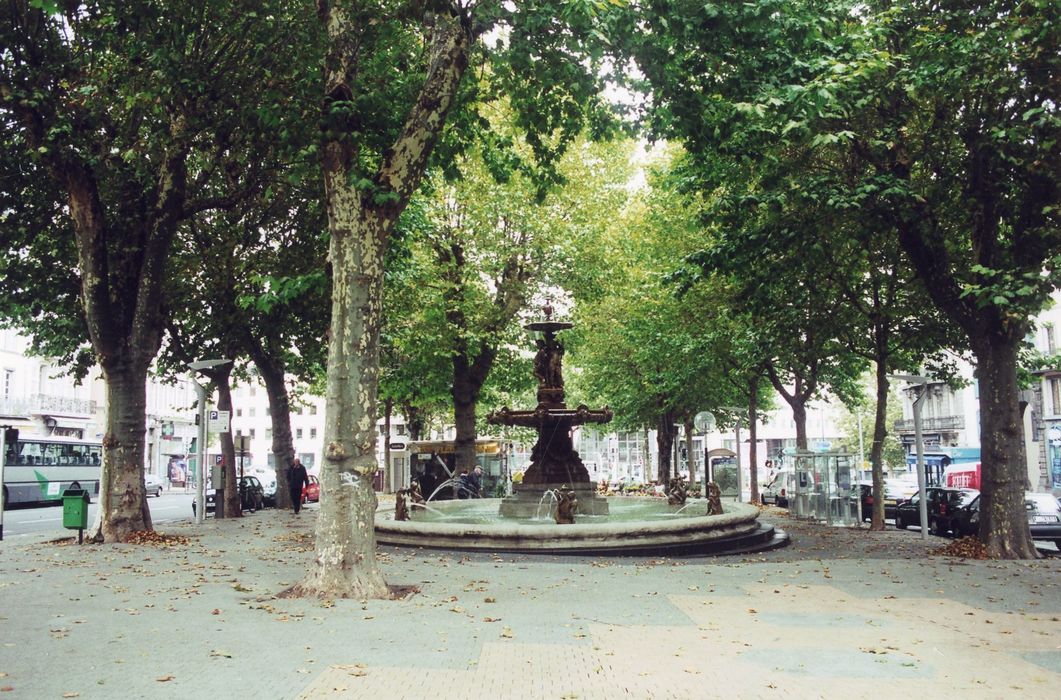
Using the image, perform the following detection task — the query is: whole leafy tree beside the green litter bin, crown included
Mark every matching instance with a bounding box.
[0,1,311,542]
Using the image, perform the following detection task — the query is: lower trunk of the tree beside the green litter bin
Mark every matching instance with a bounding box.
[89,363,152,542]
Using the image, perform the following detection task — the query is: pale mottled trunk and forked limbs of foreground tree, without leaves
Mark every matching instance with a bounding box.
[291,2,470,598]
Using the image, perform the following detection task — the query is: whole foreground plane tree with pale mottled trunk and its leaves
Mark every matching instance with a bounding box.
[301,0,610,597]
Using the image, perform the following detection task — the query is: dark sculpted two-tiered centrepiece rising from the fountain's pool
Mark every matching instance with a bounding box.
[486,304,612,518]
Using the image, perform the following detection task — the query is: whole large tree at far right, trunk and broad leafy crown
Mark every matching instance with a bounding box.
[619,2,1061,557]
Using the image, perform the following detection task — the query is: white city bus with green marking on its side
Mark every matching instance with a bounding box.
[3,435,103,508]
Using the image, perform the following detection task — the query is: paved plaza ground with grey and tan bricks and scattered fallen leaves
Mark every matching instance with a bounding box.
[0,509,1061,700]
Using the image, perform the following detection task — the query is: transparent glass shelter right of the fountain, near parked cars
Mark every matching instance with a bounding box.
[788,450,862,527]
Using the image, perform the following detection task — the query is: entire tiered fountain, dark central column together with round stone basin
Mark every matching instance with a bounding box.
[376,307,788,557]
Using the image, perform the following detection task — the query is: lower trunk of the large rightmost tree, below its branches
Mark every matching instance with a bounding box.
[973,336,1039,559]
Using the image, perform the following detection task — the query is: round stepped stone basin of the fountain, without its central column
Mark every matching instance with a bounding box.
[376,497,788,556]
